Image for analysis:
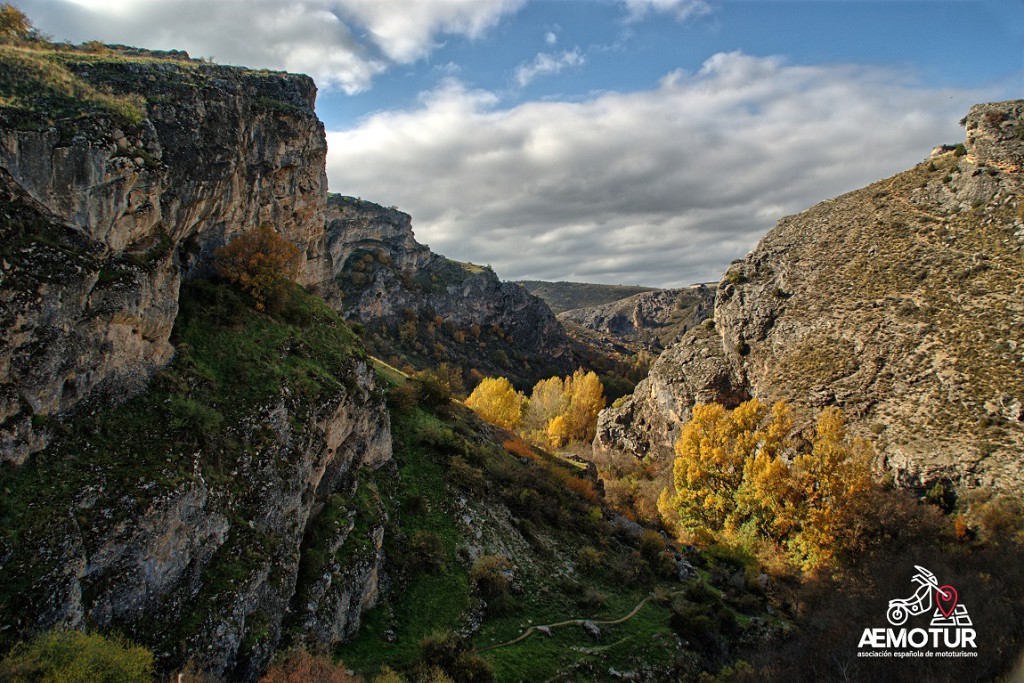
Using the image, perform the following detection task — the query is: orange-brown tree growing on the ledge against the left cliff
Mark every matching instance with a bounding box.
[214,224,301,310]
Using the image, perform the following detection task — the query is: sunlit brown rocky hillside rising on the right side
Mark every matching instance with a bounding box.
[595,101,1024,497]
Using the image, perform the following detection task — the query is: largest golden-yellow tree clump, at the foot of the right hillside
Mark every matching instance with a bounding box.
[658,399,871,569]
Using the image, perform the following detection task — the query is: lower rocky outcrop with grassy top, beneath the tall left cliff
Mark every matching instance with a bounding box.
[0,286,394,681]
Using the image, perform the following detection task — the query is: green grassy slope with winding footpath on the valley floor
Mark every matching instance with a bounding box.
[336,369,782,681]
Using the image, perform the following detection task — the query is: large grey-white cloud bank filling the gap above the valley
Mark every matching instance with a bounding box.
[328,53,994,286]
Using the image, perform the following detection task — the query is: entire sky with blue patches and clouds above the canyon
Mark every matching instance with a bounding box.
[13,0,1024,287]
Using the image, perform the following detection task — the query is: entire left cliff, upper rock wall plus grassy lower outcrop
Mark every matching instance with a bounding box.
[0,44,393,681]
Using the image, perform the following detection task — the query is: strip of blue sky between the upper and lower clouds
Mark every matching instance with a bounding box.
[321,0,1024,127]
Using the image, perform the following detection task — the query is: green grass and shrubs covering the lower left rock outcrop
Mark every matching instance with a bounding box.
[0,281,369,679]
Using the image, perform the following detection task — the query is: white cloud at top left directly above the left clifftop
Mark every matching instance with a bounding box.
[18,0,525,93]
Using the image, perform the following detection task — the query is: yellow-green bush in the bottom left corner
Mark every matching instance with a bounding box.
[0,630,153,683]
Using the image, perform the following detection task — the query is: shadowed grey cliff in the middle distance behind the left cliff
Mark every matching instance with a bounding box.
[324,196,572,386]
